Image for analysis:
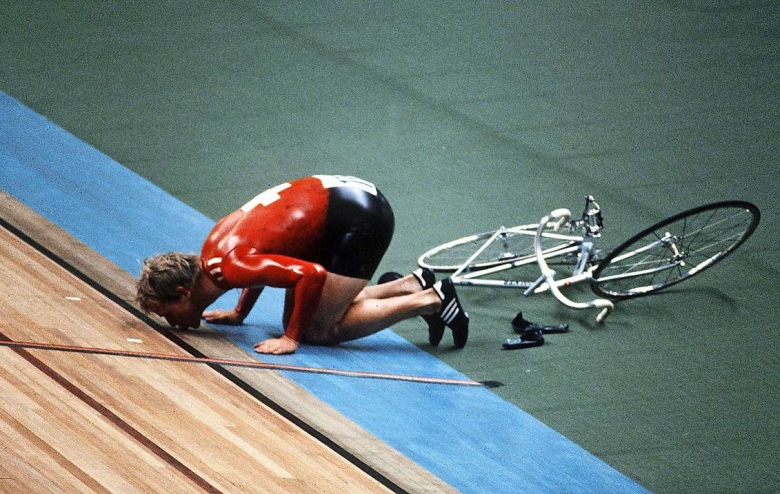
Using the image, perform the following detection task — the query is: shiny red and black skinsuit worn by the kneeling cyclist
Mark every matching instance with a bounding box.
[201,175,394,341]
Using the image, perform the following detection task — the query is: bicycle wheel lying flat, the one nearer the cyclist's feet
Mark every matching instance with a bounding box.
[417,225,574,273]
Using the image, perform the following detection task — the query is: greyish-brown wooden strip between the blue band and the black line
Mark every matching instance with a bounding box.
[0,190,458,493]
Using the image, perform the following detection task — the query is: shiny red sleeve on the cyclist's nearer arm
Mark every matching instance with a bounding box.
[222,247,328,341]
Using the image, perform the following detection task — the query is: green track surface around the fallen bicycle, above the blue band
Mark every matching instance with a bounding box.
[0,0,780,493]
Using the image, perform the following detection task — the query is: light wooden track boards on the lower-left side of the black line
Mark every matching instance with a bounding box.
[0,225,388,493]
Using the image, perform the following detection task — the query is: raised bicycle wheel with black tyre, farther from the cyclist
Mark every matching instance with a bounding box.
[591,201,761,299]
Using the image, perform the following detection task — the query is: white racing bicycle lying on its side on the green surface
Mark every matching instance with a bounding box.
[418,195,761,323]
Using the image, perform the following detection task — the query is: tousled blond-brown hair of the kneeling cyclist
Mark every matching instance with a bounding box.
[135,252,200,312]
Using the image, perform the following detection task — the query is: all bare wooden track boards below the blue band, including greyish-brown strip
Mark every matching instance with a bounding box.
[0,193,454,493]
